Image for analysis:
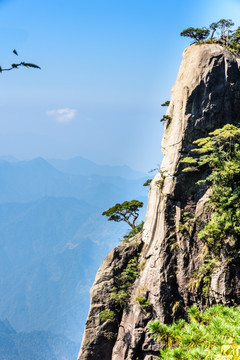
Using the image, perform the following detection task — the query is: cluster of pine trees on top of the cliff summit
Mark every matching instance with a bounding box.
[180,19,240,55]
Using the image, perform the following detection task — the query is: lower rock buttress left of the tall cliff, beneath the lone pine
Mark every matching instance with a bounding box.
[78,234,142,360]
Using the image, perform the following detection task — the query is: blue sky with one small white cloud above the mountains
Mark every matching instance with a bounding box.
[0,0,240,172]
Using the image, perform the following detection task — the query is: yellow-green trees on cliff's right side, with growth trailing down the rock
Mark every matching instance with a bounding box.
[182,124,240,295]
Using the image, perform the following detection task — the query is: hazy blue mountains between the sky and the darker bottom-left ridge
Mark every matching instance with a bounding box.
[0,158,147,360]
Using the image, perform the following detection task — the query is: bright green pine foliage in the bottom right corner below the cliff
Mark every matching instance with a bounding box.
[149,305,240,360]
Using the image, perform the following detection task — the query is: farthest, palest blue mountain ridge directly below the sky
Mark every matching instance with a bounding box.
[0,158,146,209]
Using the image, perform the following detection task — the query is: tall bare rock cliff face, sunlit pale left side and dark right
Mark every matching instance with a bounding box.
[79,44,240,360]
